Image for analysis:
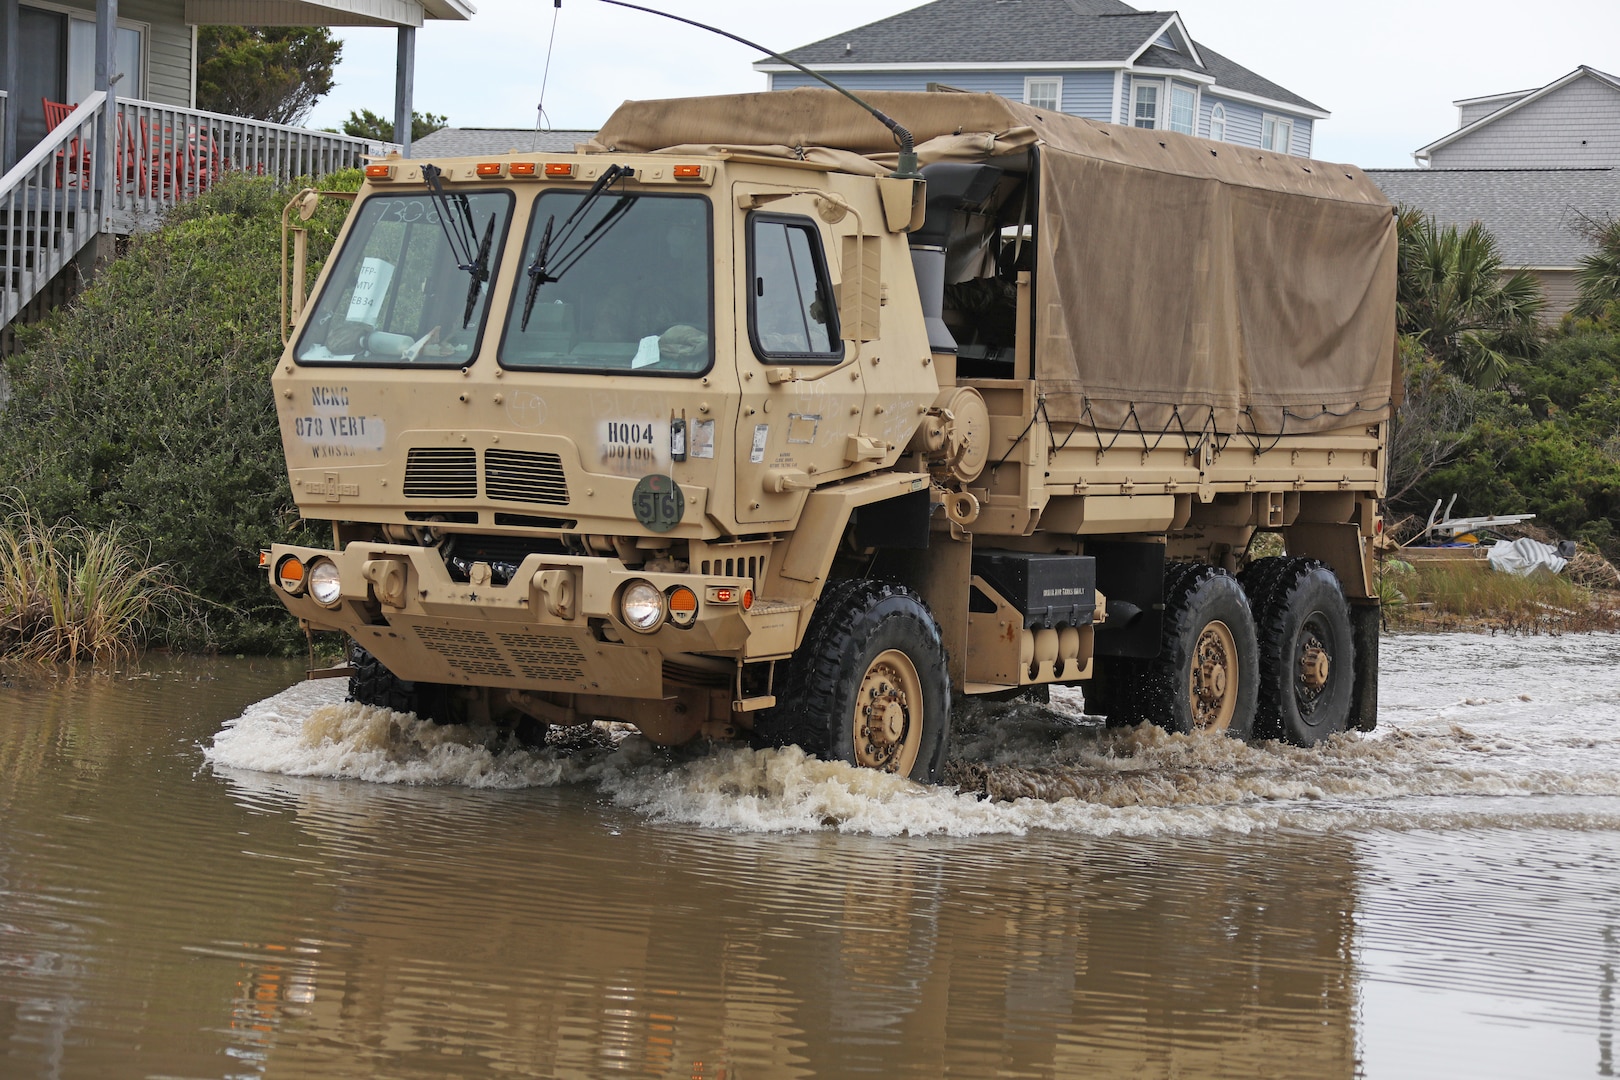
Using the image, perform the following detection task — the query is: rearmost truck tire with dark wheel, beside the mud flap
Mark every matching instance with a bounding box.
[1243,555,1356,746]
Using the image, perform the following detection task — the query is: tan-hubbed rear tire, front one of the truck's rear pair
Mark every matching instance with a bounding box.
[1132,563,1259,740]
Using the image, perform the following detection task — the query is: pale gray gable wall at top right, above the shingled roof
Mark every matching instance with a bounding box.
[1429,78,1620,168]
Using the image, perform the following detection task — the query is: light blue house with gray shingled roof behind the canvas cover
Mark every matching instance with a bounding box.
[753,0,1328,155]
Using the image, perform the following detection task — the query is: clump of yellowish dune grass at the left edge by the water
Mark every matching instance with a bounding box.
[0,499,193,664]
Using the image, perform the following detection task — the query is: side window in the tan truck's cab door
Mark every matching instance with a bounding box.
[748,214,844,363]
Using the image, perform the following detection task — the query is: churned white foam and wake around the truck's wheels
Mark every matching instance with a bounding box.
[204,636,1620,836]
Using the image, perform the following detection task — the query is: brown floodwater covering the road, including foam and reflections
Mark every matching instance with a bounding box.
[0,635,1620,1080]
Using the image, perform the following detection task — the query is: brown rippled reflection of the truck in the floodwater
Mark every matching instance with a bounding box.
[205,772,1356,1077]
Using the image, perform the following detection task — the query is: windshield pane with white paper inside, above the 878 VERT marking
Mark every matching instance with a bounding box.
[295,191,514,368]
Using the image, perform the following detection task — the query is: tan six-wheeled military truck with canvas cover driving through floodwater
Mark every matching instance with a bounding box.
[267,89,1398,780]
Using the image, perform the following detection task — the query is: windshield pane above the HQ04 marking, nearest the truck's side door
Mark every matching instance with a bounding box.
[501,189,714,376]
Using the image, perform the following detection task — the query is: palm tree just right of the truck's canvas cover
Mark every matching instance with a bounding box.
[1396,207,1545,387]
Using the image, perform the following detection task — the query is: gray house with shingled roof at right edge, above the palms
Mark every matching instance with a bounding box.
[1367,66,1620,322]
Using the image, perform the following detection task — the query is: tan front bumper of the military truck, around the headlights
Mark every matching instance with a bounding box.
[267,542,800,699]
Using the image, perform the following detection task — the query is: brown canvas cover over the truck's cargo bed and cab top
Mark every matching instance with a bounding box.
[586,89,1398,436]
